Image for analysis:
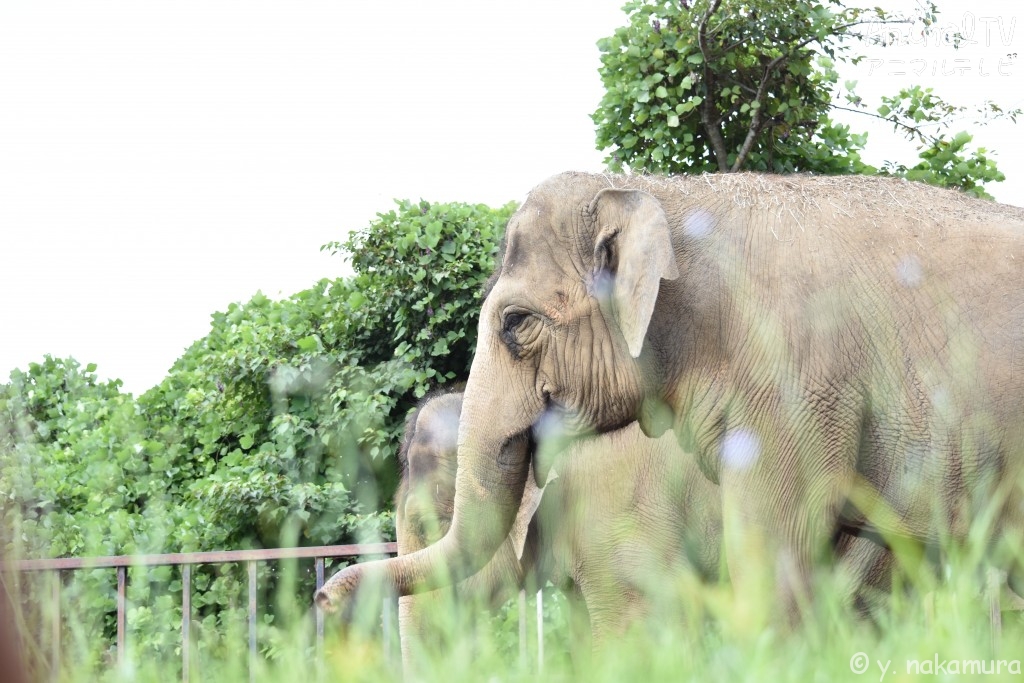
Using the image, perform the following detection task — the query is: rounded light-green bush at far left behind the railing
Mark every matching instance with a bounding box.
[0,356,181,667]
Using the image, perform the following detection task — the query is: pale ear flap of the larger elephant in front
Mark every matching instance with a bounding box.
[590,188,679,358]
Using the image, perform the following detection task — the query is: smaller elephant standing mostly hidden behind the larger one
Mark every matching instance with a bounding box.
[395,393,892,667]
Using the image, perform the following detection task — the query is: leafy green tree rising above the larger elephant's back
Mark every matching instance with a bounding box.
[592,0,1019,197]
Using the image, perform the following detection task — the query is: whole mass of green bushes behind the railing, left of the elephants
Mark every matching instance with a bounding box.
[0,196,514,678]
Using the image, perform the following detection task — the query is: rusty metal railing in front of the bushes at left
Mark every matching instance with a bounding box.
[2,543,398,681]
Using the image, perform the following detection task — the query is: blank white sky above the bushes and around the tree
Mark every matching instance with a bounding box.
[0,0,1024,393]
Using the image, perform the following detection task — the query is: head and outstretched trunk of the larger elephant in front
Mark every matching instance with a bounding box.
[315,174,679,610]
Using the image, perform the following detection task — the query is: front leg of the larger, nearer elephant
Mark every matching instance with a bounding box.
[720,397,859,626]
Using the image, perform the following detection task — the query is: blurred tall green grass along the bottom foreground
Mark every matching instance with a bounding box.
[4,532,1024,683]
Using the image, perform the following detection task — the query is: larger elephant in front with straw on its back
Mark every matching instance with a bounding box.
[316,173,1024,616]
